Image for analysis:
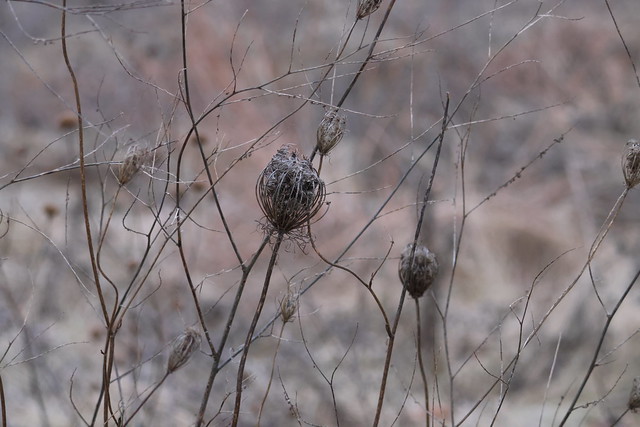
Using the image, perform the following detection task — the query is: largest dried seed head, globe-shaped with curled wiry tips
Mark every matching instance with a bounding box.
[256,145,326,234]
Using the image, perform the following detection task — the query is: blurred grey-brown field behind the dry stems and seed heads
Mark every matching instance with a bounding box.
[0,0,640,426]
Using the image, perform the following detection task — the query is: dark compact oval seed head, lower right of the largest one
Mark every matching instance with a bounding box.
[398,243,438,298]
